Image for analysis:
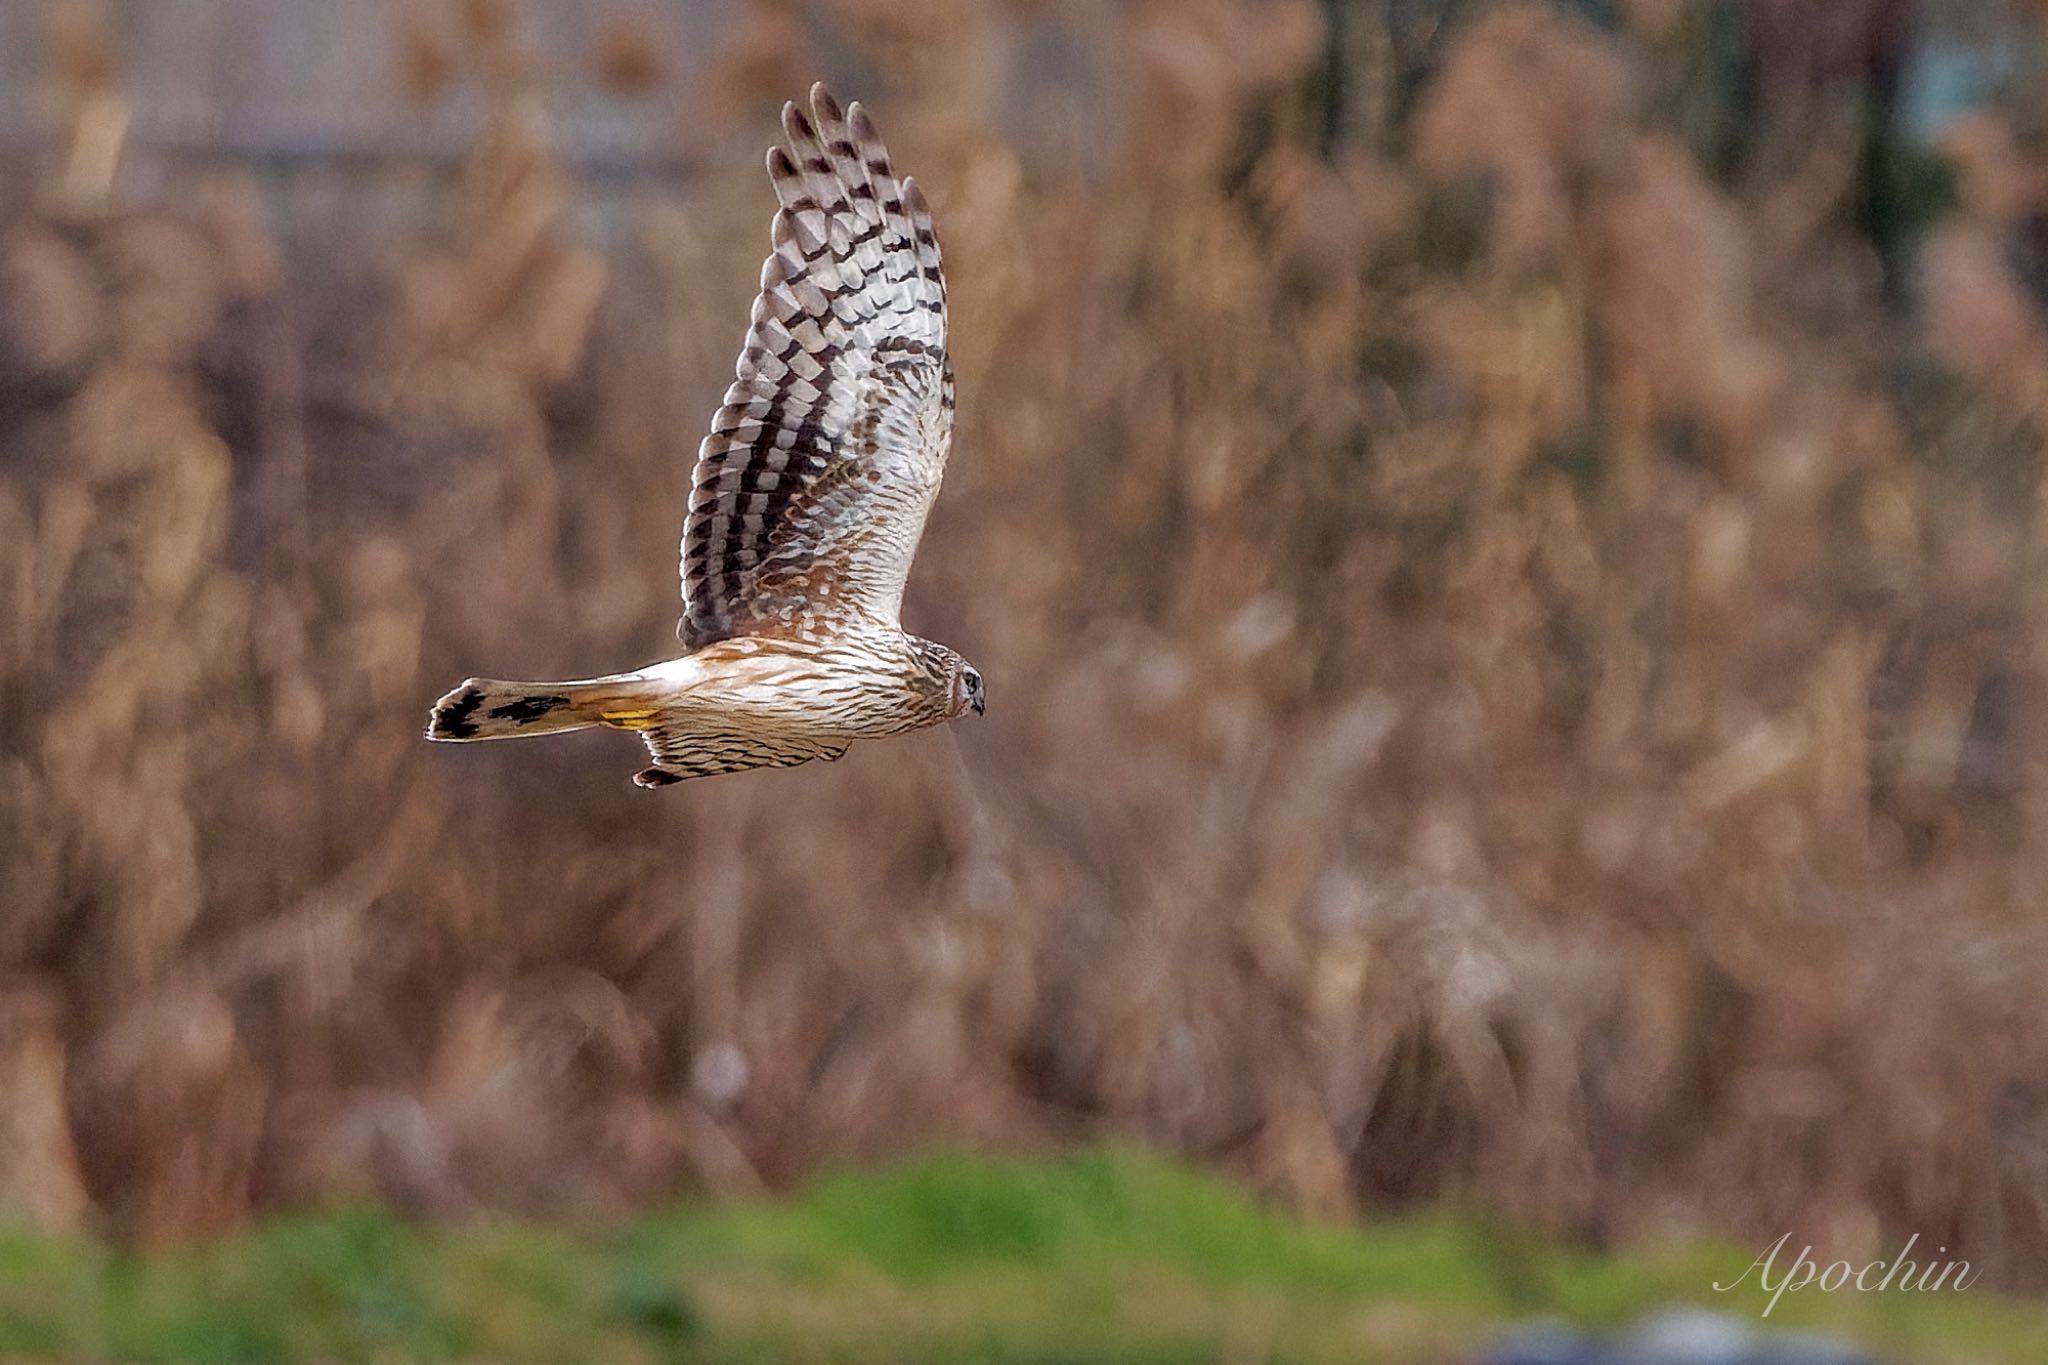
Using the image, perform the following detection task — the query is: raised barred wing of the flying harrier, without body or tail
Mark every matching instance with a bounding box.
[678,86,952,649]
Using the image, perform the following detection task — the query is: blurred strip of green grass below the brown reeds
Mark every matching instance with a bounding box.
[0,1150,2048,1365]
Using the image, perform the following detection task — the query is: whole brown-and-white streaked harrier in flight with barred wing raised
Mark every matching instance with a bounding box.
[426,86,983,788]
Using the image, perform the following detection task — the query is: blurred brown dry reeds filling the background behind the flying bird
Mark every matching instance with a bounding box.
[0,0,2048,1291]
